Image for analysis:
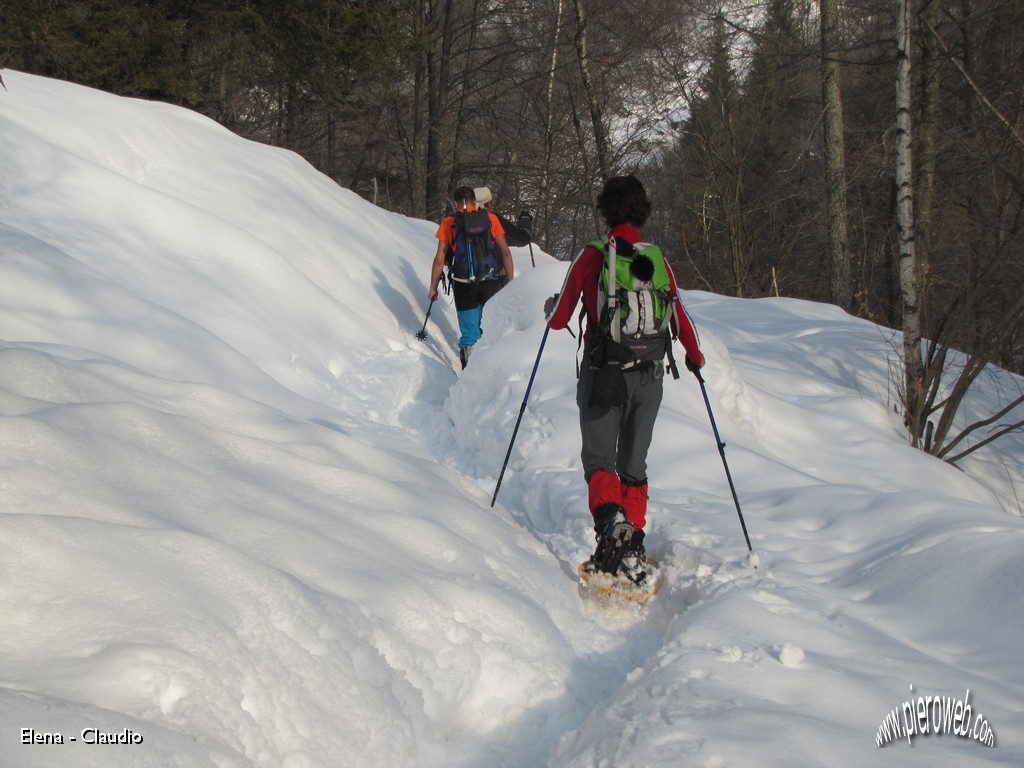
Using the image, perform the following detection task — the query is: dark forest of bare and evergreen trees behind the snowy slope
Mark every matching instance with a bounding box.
[0,0,1024,460]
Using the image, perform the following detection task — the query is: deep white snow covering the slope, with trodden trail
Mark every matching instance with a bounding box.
[0,71,1024,768]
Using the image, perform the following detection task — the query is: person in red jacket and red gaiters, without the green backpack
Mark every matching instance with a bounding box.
[545,176,705,583]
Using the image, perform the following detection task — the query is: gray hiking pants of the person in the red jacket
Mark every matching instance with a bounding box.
[577,355,665,482]
